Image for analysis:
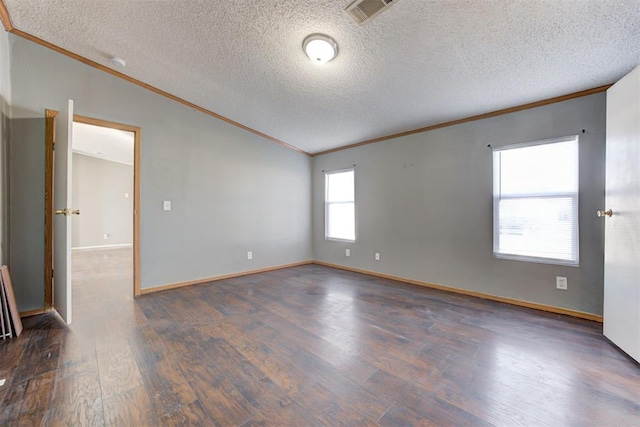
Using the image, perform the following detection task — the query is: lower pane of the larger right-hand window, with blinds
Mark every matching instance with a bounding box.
[496,197,578,261]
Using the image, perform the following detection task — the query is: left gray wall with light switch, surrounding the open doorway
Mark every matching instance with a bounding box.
[9,35,312,310]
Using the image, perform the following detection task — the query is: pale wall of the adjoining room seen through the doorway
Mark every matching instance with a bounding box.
[71,153,133,248]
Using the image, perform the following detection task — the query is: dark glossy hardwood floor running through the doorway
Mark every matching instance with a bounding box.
[0,250,640,426]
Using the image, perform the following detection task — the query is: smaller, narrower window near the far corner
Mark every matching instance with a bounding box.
[325,169,356,241]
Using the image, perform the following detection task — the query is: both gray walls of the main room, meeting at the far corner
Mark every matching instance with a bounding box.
[3,35,605,314]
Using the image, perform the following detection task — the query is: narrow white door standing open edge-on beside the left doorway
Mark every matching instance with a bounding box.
[53,99,73,324]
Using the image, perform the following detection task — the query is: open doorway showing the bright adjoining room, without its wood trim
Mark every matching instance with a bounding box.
[71,123,134,311]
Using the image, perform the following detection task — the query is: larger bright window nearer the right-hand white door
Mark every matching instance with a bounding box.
[493,136,578,265]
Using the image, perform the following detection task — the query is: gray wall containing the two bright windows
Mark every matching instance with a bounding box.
[313,93,606,314]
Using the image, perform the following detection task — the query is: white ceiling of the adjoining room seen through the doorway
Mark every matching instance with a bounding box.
[71,122,134,165]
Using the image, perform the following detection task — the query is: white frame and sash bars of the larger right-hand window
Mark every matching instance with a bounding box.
[493,135,580,267]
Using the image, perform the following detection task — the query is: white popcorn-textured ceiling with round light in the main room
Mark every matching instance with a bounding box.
[4,0,640,153]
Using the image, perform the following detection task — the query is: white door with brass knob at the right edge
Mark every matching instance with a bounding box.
[602,67,640,361]
